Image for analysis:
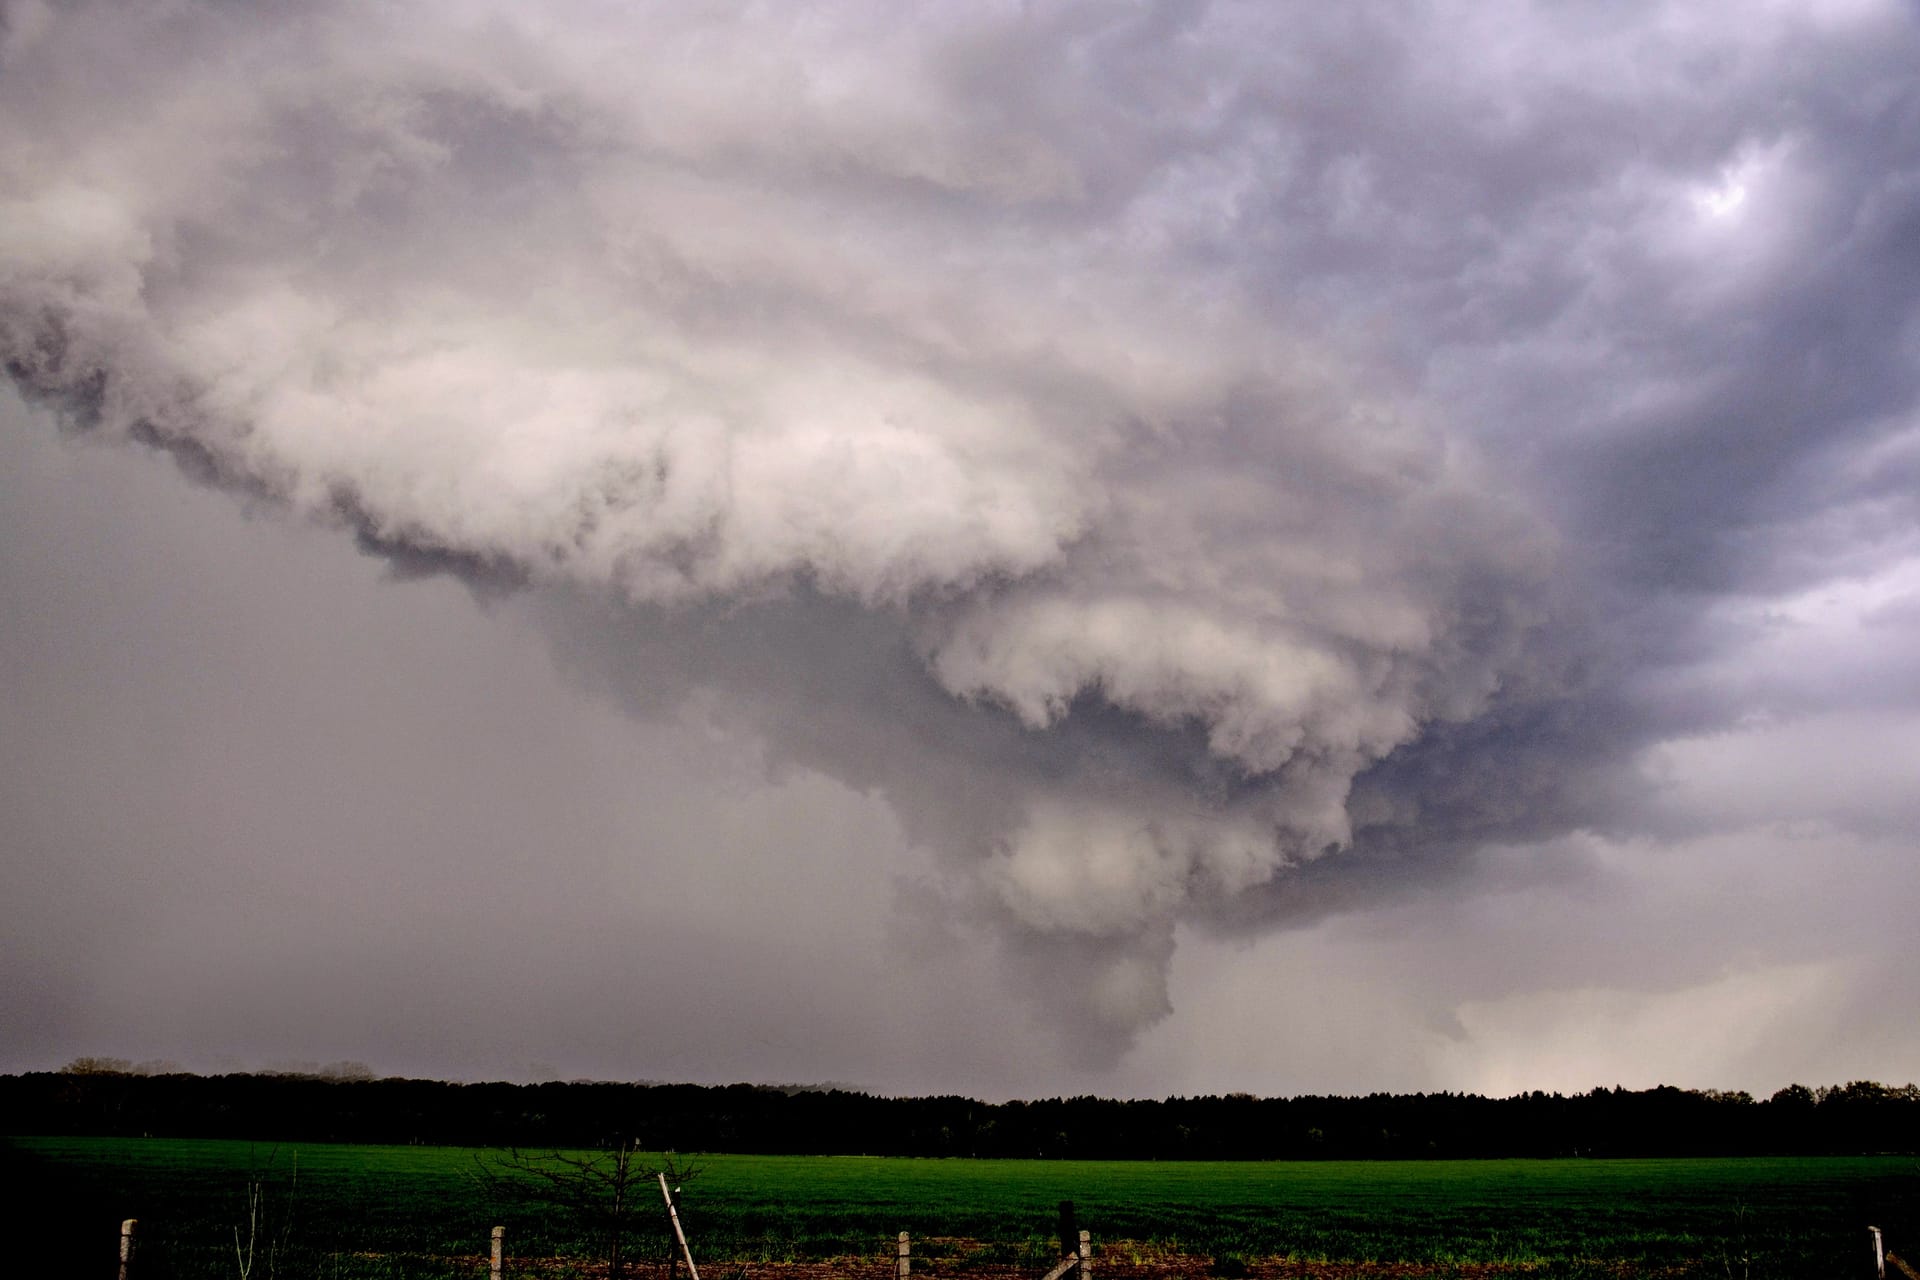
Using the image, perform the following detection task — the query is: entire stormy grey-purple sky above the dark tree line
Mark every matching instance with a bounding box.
[0,0,1920,1100]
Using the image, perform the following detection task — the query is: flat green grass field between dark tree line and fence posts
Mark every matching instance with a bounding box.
[0,1138,1920,1280]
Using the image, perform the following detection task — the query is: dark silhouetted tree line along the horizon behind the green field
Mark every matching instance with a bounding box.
[0,1059,1920,1159]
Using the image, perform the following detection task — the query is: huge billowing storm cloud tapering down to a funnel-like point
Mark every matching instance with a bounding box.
[0,4,1920,1055]
